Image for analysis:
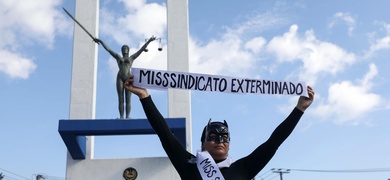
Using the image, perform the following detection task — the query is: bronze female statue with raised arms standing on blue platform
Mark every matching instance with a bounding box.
[93,36,156,119]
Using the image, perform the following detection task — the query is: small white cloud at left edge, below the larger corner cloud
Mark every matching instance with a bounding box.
[0,50,37,79]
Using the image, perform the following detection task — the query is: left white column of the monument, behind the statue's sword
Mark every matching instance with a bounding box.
[67,0,99,178]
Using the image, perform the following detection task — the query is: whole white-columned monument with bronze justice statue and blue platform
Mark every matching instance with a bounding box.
[58,0,192,180]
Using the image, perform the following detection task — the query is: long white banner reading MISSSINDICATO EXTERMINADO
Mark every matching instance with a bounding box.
[131,68,308,97]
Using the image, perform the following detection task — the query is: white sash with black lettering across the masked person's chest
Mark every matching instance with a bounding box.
[196,151,225,180]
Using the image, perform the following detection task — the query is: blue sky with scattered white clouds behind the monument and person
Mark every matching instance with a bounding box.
[0,0,390,180]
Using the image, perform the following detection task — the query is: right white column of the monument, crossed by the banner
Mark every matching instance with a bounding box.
[167,0,192,152]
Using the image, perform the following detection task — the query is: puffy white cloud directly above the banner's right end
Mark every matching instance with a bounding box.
[266,25,356,84]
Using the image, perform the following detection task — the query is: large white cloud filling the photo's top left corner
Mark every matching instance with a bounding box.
[0,0,66,47]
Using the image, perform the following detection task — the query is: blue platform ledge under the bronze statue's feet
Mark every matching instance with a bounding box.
[58,118,186,159]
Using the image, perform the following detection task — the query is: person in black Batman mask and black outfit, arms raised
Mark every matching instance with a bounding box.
[125,76,314,180]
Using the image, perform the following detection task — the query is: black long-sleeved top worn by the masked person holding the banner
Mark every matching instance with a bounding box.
[141,96,303,180]
